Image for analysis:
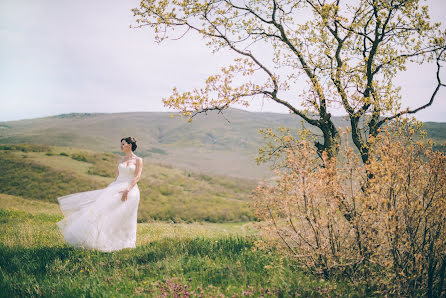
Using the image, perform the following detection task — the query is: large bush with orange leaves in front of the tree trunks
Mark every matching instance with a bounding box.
[252,120,446,297]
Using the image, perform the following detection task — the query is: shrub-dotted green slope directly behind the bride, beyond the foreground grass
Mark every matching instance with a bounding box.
[0,144,255,223]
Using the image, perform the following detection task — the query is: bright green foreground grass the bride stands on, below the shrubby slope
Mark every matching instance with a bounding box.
[0,195,358,297]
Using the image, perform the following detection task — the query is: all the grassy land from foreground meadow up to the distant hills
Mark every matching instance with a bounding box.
[0,111,445,297]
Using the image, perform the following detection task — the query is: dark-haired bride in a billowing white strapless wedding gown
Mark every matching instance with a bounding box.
[57,137,142,252]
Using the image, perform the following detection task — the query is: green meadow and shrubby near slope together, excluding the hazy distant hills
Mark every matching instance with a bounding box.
[0,144,368,297]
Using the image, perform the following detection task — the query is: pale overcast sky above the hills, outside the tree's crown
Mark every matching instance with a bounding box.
[0,0,446,122]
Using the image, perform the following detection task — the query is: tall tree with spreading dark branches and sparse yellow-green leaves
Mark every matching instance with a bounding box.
[132,0,446,163]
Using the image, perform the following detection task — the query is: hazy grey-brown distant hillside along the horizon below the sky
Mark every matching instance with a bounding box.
[0,109,446,179]
